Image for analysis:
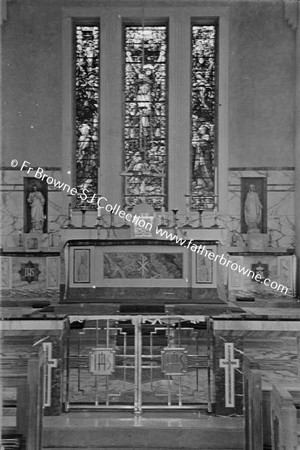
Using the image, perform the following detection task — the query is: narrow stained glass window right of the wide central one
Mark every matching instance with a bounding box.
[191,25,216,209]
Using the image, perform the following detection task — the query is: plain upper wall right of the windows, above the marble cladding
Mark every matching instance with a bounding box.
[229,2,295,169]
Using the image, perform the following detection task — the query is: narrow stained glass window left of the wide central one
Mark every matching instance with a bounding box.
[75,25,100,208]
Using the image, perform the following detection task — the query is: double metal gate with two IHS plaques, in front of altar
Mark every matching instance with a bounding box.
[64,315,212,414]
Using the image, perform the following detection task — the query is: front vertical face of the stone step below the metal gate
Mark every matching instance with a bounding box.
[43,423,244,450]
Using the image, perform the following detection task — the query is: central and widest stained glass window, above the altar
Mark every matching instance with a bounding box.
[122,26,167,209]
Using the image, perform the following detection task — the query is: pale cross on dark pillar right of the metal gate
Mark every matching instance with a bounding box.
[220,342,240,408]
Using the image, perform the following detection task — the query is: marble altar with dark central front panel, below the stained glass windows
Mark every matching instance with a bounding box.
[62,239,218,304]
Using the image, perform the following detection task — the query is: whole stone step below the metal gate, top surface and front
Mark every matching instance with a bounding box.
[43,412,244,450]
